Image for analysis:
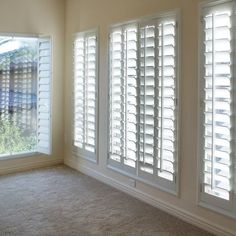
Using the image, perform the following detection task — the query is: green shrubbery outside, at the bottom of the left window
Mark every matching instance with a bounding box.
[0,118,36,155]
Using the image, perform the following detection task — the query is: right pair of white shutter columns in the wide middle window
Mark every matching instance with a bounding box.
[139,20,177,189]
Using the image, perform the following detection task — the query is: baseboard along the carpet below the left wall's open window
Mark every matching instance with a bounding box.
[0,159,63,175]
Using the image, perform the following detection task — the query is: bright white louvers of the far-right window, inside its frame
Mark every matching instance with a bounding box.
[203,11,233,200]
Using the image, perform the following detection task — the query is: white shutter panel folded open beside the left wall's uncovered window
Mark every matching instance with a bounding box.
[37,37,52,154]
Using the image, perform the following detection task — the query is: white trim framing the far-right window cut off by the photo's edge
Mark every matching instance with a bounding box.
[196,0,236,219]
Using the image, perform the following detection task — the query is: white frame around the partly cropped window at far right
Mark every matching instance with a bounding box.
[196,0,236,219]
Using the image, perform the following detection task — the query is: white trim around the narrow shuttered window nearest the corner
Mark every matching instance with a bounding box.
[71,27,99,164]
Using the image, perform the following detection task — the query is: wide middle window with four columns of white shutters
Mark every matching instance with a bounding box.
[108,13,178,193]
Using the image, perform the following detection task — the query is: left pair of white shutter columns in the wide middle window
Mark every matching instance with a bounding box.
[109,24,137,173]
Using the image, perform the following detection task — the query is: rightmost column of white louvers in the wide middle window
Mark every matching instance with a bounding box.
[157,20,177,181]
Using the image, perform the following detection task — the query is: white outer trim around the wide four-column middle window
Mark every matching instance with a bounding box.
[106,9,181,197]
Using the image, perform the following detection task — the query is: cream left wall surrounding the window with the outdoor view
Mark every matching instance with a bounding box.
[0,0,64,174]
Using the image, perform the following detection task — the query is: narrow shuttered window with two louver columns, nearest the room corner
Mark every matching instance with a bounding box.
[74,31,97,160]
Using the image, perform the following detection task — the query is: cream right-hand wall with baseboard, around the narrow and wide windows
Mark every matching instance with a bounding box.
[65,0,236,235]
